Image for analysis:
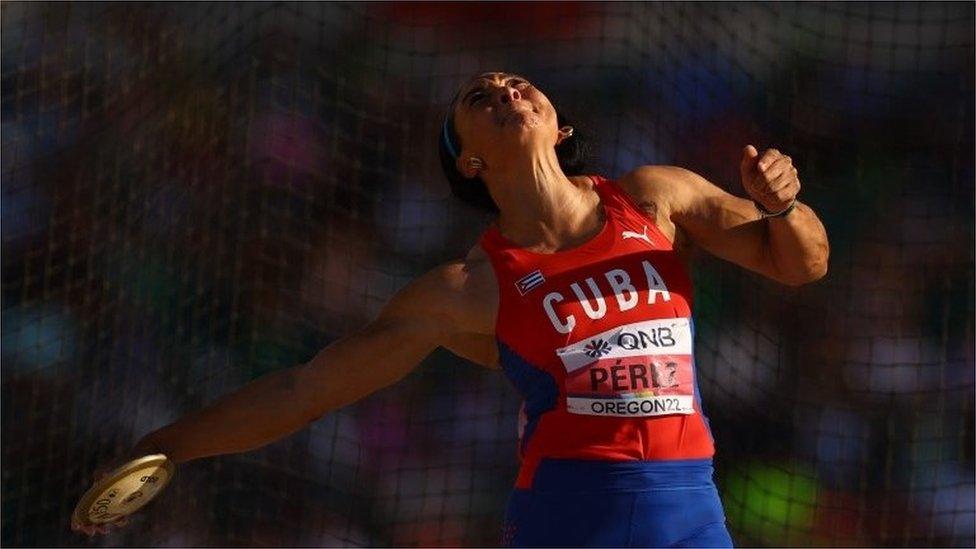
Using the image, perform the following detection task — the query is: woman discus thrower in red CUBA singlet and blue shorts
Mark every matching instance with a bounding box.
[72,72,829,547]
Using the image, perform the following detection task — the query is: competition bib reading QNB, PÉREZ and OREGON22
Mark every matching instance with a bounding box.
[556,318,695,417]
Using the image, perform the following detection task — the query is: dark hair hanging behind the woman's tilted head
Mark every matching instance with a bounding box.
[437,110,586,213]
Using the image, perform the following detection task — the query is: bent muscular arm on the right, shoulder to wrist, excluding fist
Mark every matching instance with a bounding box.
[621,166,829,286]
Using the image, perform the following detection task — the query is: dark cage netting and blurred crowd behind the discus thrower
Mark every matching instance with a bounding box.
[0,2,976,546]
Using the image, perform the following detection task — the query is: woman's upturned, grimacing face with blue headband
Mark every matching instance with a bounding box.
[454,72,559,173]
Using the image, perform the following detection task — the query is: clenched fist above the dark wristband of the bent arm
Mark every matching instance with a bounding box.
[739,145,800,213]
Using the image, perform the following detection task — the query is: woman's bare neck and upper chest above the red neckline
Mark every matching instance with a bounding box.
[486,152,603,251]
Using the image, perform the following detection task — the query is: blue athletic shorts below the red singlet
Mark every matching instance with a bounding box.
[502,459,732,547]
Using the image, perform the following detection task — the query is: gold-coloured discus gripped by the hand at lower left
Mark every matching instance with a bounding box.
[71,452,175,536]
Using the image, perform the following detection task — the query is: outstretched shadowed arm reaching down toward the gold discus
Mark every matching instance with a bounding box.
[134,263,480,463]
